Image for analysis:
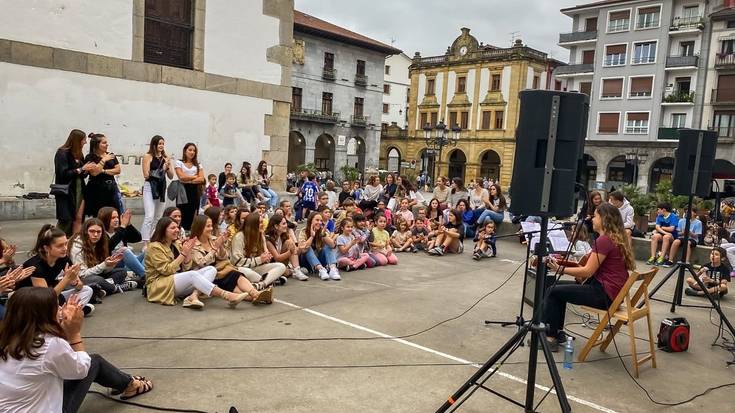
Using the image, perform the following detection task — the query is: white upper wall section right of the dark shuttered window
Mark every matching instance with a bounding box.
[204,0,281,84]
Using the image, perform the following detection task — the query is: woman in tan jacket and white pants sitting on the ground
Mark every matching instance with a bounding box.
[145,217,248,309]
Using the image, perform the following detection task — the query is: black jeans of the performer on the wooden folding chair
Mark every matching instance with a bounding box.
[542,278,612,337]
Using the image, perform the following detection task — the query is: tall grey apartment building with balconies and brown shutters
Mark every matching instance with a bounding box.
[554,0,735,191]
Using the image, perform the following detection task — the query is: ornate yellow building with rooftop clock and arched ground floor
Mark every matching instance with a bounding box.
[380,28,562,186]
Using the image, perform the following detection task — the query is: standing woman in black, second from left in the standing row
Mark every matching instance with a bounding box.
[84,133,120,217]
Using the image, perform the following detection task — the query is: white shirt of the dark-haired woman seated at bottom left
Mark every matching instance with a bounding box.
[0,335,91,413]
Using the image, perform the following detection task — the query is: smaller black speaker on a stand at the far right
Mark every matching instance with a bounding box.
[671,129,717,197]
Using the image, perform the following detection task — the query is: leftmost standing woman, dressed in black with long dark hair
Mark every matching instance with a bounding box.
[51,129,97,236]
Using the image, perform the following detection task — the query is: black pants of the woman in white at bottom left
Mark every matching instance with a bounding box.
[63,354,133,413]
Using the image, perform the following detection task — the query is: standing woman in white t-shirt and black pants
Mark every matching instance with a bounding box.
[176,142,205,231]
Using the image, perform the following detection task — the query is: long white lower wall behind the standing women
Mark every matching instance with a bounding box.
[0,63,272,195]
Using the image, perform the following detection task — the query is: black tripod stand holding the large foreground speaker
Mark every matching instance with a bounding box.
[437,216,572,412]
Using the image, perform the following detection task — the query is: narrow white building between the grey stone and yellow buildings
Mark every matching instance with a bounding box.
[381,53,411,130]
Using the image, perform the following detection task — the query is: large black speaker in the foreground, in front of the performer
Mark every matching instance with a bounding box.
[510,90,589,216]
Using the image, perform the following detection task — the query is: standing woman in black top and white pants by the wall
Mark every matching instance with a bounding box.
[141,135,174,244]
